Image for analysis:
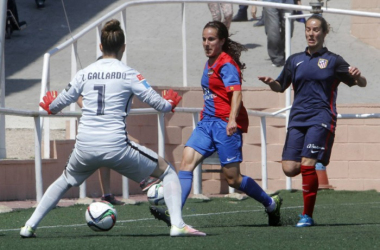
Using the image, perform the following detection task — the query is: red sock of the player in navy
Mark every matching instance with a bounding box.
[301,165,319,217]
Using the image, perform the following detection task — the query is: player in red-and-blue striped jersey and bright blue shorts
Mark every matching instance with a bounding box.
[151,21,281,226]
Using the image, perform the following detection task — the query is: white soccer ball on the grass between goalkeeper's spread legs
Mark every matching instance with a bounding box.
[86,201,117,232]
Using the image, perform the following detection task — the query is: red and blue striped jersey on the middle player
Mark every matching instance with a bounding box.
[201,52,248,133]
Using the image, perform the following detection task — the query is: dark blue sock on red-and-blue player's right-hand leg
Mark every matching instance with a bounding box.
[239,175,273,207]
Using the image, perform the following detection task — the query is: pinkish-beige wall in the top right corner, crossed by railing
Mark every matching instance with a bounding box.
[351,0,380,49]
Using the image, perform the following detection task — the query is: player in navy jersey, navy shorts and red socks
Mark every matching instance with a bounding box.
[258,15,367,227]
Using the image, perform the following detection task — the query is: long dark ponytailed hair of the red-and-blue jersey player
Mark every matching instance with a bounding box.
[203,21,247,70]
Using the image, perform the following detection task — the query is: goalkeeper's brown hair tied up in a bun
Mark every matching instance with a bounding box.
[100,19,125,55]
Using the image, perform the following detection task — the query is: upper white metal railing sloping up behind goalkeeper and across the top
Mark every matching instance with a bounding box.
[36,0,380,160]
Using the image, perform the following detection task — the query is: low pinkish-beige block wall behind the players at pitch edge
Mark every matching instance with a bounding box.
[0,88,380,200]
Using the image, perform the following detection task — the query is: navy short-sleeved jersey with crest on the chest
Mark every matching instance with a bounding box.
[277,48,355,132]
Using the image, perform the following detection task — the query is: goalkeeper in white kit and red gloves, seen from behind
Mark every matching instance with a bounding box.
[20,20,206,238]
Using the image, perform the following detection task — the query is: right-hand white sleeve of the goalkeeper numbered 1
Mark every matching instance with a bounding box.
[131,71,172,113]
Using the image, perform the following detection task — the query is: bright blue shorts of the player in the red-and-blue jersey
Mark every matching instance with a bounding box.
[185,118,243,167]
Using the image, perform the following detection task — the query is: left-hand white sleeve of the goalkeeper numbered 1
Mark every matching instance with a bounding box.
[49,71,85,113]
